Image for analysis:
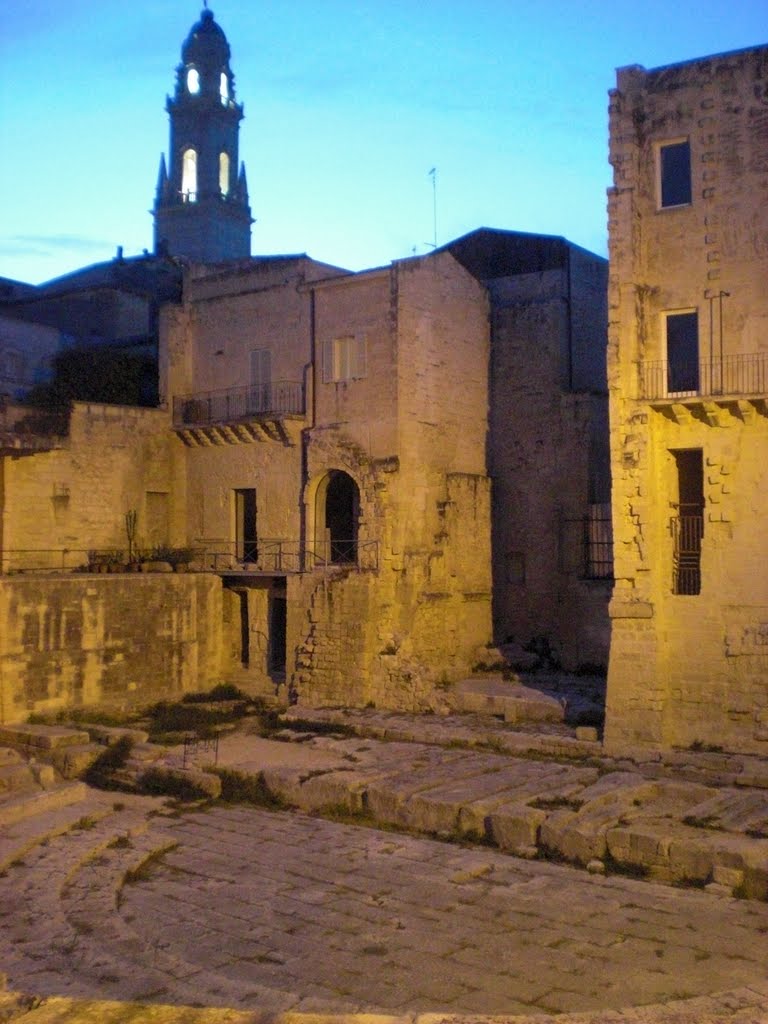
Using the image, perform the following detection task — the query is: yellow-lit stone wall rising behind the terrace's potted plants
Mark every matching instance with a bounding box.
[2,402,185,569]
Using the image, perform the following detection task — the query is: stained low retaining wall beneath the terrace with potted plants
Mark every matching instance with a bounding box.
[0,573,222,722]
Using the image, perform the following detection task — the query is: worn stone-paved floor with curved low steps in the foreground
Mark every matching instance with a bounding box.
[0,801,768,1024]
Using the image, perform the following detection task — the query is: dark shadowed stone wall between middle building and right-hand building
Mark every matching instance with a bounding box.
[488,268,610,668]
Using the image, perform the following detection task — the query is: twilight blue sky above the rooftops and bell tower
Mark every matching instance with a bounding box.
[0,0,768,283]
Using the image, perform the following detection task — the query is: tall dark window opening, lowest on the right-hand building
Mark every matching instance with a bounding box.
[672,449,705,595]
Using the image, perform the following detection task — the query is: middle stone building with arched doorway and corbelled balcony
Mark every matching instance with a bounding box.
[163,253,490,709]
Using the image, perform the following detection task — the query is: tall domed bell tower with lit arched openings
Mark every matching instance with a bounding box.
[154,2,252,263]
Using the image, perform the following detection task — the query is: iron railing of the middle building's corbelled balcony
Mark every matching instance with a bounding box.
[173,381,305,427]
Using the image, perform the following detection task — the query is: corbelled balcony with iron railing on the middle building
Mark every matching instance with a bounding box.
[173,381,305,447]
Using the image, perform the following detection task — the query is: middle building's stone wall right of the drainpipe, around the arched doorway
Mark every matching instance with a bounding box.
[289,254,490,710]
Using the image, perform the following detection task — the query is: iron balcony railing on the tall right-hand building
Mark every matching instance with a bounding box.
[640,352,768,399]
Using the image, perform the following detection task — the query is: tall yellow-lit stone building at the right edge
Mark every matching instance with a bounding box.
[605,46,768,753]
